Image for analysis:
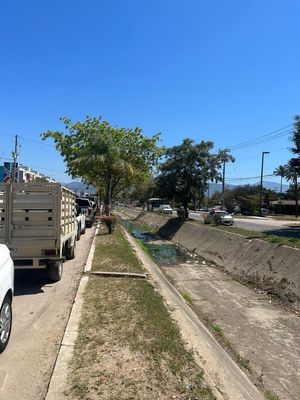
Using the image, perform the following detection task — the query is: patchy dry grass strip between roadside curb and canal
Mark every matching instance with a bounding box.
[65,226,215,400]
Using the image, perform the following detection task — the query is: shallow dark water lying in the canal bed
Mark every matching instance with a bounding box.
[122,220,200,266]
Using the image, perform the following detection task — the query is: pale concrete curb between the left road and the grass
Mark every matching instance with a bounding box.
[45,224,99,400]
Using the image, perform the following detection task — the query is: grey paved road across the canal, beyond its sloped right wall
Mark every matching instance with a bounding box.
[189,212,300,237]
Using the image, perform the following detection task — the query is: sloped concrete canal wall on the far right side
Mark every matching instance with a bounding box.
[119,209,300,311]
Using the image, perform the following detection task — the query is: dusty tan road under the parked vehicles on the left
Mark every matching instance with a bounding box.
[0,227,95,400]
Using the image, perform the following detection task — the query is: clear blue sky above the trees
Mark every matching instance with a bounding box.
[0,0,300,188]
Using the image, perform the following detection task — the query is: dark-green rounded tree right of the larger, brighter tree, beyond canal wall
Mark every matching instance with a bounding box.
[156,139,234,217]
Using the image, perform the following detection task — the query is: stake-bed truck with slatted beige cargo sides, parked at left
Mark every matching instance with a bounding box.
[0,182,77,282]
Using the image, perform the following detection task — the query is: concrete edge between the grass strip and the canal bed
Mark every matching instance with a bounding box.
[122,227,264,400]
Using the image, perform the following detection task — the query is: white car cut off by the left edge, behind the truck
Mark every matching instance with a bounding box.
[0,244,14,353]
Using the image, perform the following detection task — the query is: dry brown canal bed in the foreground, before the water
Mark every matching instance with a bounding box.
[163,260,300,400]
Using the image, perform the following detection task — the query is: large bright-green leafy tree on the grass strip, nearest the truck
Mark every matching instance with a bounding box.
[41,117,162,215]
